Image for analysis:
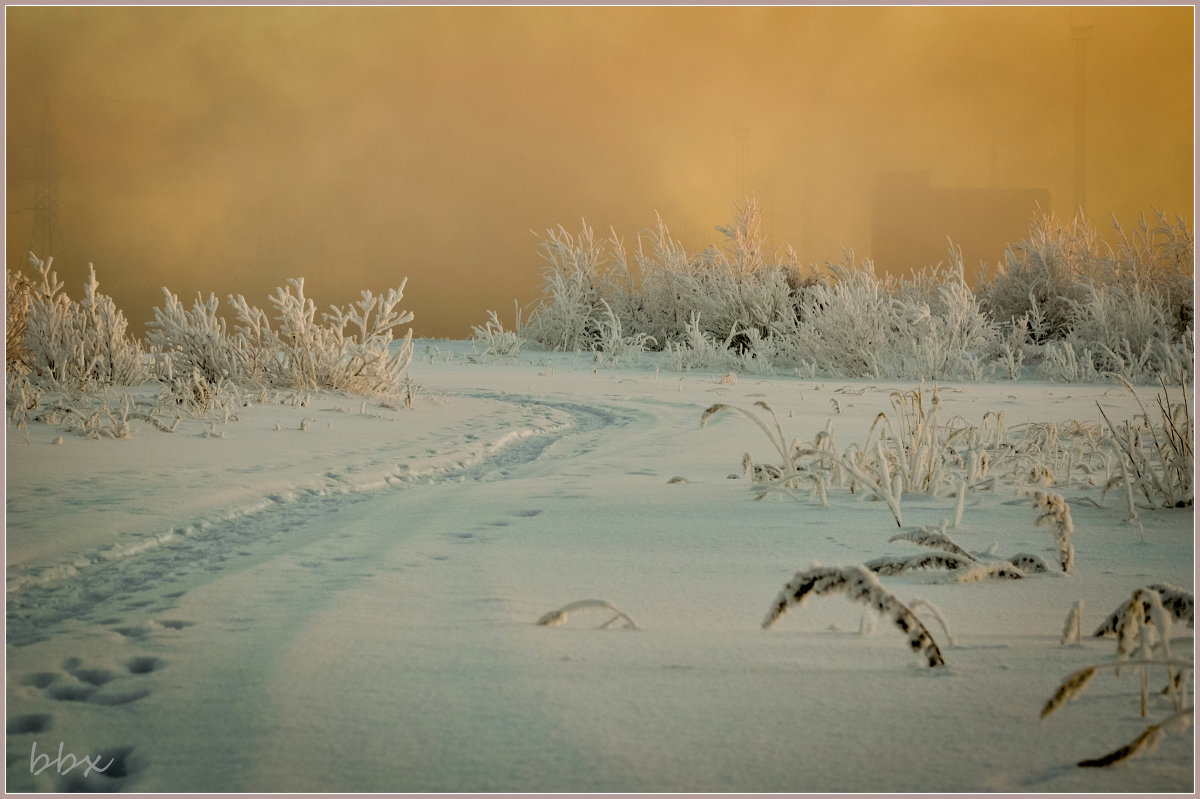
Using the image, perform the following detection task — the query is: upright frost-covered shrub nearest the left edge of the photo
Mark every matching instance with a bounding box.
[25,254,148,391]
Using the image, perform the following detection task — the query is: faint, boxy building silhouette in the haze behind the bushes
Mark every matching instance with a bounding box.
[870,172,1050,283]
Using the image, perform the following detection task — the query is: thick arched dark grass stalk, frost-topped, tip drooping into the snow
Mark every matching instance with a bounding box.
[762,564,946,667]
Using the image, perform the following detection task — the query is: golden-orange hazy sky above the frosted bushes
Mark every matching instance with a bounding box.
[6,6,1194,337]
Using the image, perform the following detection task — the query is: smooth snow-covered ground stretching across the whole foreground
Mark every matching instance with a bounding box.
[6,342,1194,792]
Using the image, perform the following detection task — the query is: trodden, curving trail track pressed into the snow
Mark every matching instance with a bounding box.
[7,391,635,647]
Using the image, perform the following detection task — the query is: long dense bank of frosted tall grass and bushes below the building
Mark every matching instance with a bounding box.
[520,200,1194,384]
